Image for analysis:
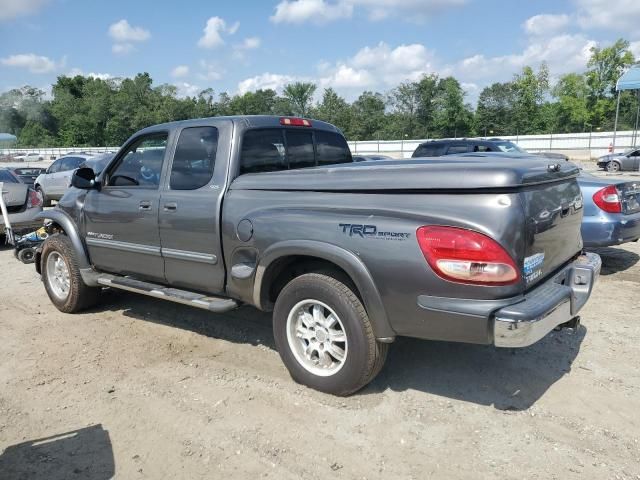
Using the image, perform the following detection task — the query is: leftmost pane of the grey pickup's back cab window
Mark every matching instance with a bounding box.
[240,129,287,175]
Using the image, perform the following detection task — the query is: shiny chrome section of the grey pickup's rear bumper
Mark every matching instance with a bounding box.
[493,253,601,347]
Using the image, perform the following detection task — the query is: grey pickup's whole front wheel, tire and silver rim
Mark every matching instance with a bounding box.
[41,233,100,313]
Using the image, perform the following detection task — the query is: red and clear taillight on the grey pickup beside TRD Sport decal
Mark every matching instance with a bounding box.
[416,226,520,285]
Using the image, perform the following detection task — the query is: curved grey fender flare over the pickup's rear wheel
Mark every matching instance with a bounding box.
[253,240,396,341]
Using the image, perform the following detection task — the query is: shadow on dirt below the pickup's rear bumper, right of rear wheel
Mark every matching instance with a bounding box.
[364,326,587,411]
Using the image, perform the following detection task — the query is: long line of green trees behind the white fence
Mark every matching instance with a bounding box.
[0,39,639,147]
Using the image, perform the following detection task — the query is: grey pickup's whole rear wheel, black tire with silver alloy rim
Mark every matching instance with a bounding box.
[273,273,389,396]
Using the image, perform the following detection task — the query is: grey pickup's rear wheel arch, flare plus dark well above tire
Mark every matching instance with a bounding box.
[253,240,396,341]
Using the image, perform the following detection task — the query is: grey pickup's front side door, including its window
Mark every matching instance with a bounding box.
[84,132,168,283]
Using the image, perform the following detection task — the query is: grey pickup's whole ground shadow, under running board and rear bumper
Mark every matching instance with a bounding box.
[96,291,587,410]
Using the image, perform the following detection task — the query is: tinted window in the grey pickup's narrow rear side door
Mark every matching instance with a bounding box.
[169,127,218,190]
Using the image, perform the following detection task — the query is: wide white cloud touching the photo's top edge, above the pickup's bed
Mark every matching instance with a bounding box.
[271,0,467,24]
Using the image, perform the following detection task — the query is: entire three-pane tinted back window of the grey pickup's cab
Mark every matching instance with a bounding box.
[240,128,353,175]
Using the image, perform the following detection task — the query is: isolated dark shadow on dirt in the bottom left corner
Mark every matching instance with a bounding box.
[0,425,115,480]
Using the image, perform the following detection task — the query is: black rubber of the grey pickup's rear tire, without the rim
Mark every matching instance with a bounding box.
[273,273,389,396]
